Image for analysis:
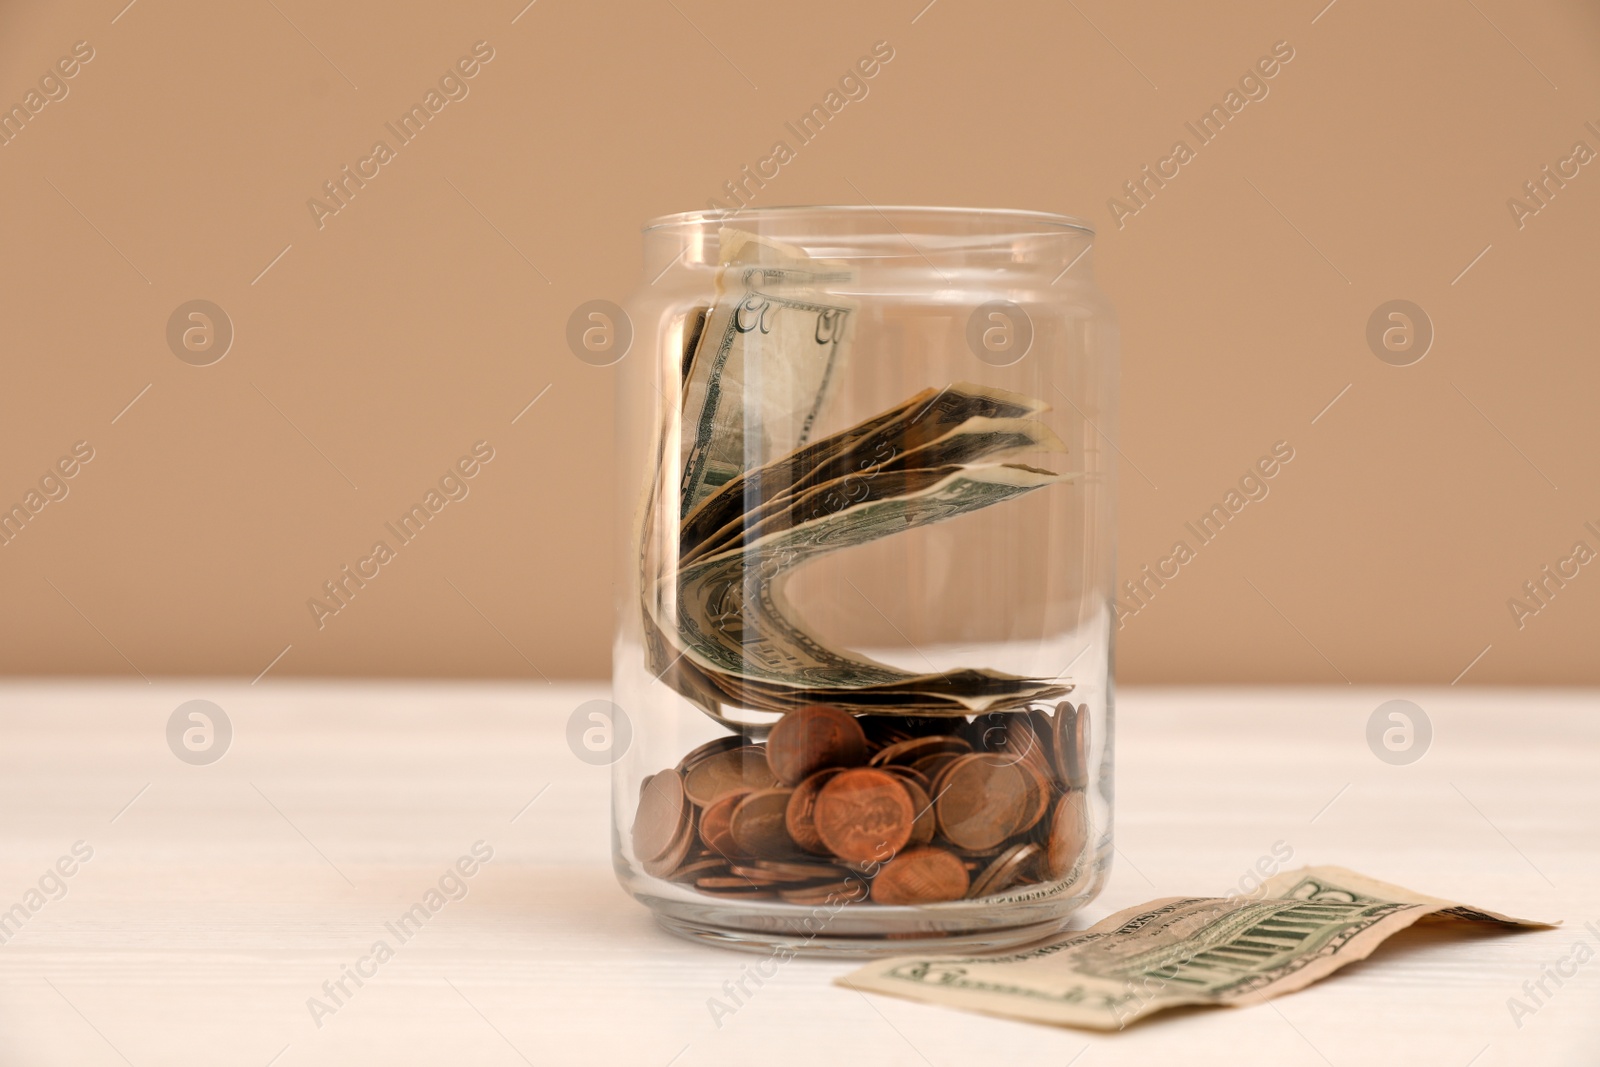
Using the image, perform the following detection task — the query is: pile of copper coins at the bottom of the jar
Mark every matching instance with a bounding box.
[632,702,1090,905]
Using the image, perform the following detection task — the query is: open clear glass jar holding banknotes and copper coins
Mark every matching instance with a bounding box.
[613,206,1117,955]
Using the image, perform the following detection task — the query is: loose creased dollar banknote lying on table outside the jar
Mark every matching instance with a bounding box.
[835,867,1555,1030]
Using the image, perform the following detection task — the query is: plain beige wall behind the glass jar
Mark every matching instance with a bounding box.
[0,0,1600,685]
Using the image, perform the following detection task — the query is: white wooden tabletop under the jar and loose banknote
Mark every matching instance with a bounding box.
[0,681,1600,1067]
